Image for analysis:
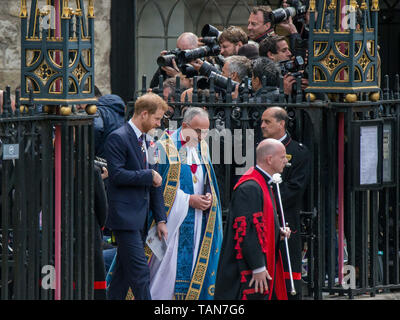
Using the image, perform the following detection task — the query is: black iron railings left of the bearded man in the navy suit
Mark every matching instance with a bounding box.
[0,89,94,300]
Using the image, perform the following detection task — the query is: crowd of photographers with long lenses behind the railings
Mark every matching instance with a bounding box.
[150,0,309,107]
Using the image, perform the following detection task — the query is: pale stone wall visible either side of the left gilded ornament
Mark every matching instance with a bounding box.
[0,0,111,94]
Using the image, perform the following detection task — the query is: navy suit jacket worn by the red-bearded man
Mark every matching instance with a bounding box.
[105,123,167,230]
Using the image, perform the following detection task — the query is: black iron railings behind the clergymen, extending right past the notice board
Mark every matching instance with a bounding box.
[127,76,400,299]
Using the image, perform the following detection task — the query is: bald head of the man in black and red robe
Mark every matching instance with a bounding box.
[256,138,287,176]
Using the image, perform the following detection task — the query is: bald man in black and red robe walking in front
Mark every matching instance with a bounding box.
[214,139,290,300]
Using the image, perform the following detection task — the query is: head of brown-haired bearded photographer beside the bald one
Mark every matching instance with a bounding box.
[218,26,248,58]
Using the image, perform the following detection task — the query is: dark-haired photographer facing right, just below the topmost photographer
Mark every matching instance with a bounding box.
[259,36,308,95]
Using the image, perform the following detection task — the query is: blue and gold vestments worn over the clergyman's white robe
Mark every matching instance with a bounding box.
[153,128,222,300]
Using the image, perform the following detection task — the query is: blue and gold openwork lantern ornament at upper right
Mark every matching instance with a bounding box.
[306,0,379,101]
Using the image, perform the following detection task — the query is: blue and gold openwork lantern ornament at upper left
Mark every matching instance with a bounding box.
[19,0,97,107]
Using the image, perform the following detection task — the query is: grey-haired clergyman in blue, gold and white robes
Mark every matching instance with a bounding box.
[149,107,222,300]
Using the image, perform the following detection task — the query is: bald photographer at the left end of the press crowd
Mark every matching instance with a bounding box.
[150,32,199,88]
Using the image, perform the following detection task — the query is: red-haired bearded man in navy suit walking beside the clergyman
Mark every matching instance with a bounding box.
[105,93,168,300]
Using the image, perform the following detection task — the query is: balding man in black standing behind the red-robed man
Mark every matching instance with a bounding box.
[261,107,311,300]
